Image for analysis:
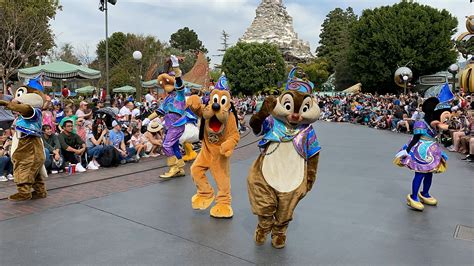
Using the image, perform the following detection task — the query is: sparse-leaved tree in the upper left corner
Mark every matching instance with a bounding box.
[0,0,61,90]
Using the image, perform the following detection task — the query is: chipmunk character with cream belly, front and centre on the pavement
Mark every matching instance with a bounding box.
[247,68,321,248]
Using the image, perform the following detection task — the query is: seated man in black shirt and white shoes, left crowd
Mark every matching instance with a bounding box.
[59,120,86,172]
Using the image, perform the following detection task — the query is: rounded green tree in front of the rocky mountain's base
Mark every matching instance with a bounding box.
[222,42,285,95]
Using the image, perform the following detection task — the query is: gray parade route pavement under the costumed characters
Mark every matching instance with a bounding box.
[0,122,474,265]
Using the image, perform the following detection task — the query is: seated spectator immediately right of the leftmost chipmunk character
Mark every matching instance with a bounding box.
[43,125,64,174]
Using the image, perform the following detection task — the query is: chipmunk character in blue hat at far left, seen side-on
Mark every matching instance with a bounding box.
[0,79,48,201]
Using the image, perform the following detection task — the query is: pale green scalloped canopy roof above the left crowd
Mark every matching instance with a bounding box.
[18,61,100,79]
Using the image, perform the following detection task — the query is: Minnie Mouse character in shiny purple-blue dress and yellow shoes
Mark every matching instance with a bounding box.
[394,84,454,211]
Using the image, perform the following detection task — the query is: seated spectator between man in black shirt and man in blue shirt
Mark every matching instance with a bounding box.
[86,121,109,170]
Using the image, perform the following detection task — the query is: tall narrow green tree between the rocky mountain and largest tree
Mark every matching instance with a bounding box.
[316,7,357,72]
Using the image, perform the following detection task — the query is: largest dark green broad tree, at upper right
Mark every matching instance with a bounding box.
[348,1,457,92]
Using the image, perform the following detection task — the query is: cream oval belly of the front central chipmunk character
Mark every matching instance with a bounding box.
[262,141,305,192]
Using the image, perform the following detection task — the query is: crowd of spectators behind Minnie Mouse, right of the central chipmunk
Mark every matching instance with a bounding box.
[317,93,474,162]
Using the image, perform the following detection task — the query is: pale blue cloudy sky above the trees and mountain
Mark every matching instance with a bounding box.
[52,0,474,66]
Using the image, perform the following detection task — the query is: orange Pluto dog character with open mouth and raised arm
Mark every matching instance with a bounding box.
[190,76,240,218]
